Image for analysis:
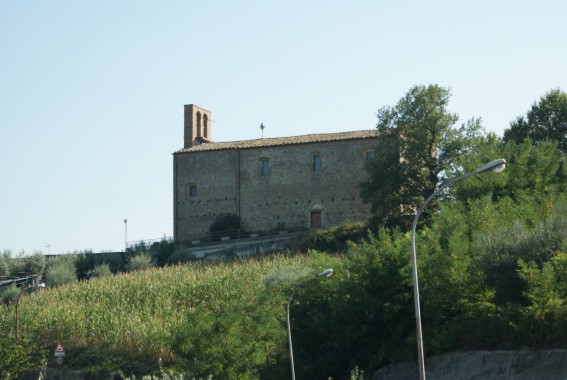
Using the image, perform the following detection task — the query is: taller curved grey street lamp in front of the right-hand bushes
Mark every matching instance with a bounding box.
[411,159,506,380]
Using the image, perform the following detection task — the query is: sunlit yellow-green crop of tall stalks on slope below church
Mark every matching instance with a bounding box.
[0,255,338,376]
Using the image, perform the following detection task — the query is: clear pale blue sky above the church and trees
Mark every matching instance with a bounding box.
[0,0,567,254]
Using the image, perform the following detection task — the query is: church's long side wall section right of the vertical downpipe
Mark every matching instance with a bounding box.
[237,140,376,230]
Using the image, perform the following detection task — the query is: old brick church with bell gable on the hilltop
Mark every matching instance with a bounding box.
[173,104,378,241]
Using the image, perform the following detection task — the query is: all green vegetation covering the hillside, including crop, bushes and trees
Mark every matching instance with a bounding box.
[0,86,567,380]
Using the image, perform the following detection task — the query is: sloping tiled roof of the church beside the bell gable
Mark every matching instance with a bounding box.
[175,129,378,154]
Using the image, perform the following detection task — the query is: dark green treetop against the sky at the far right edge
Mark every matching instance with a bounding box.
[504,89,567,152]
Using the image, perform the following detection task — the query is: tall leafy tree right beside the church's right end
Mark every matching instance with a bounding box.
[360,85,482,227]
